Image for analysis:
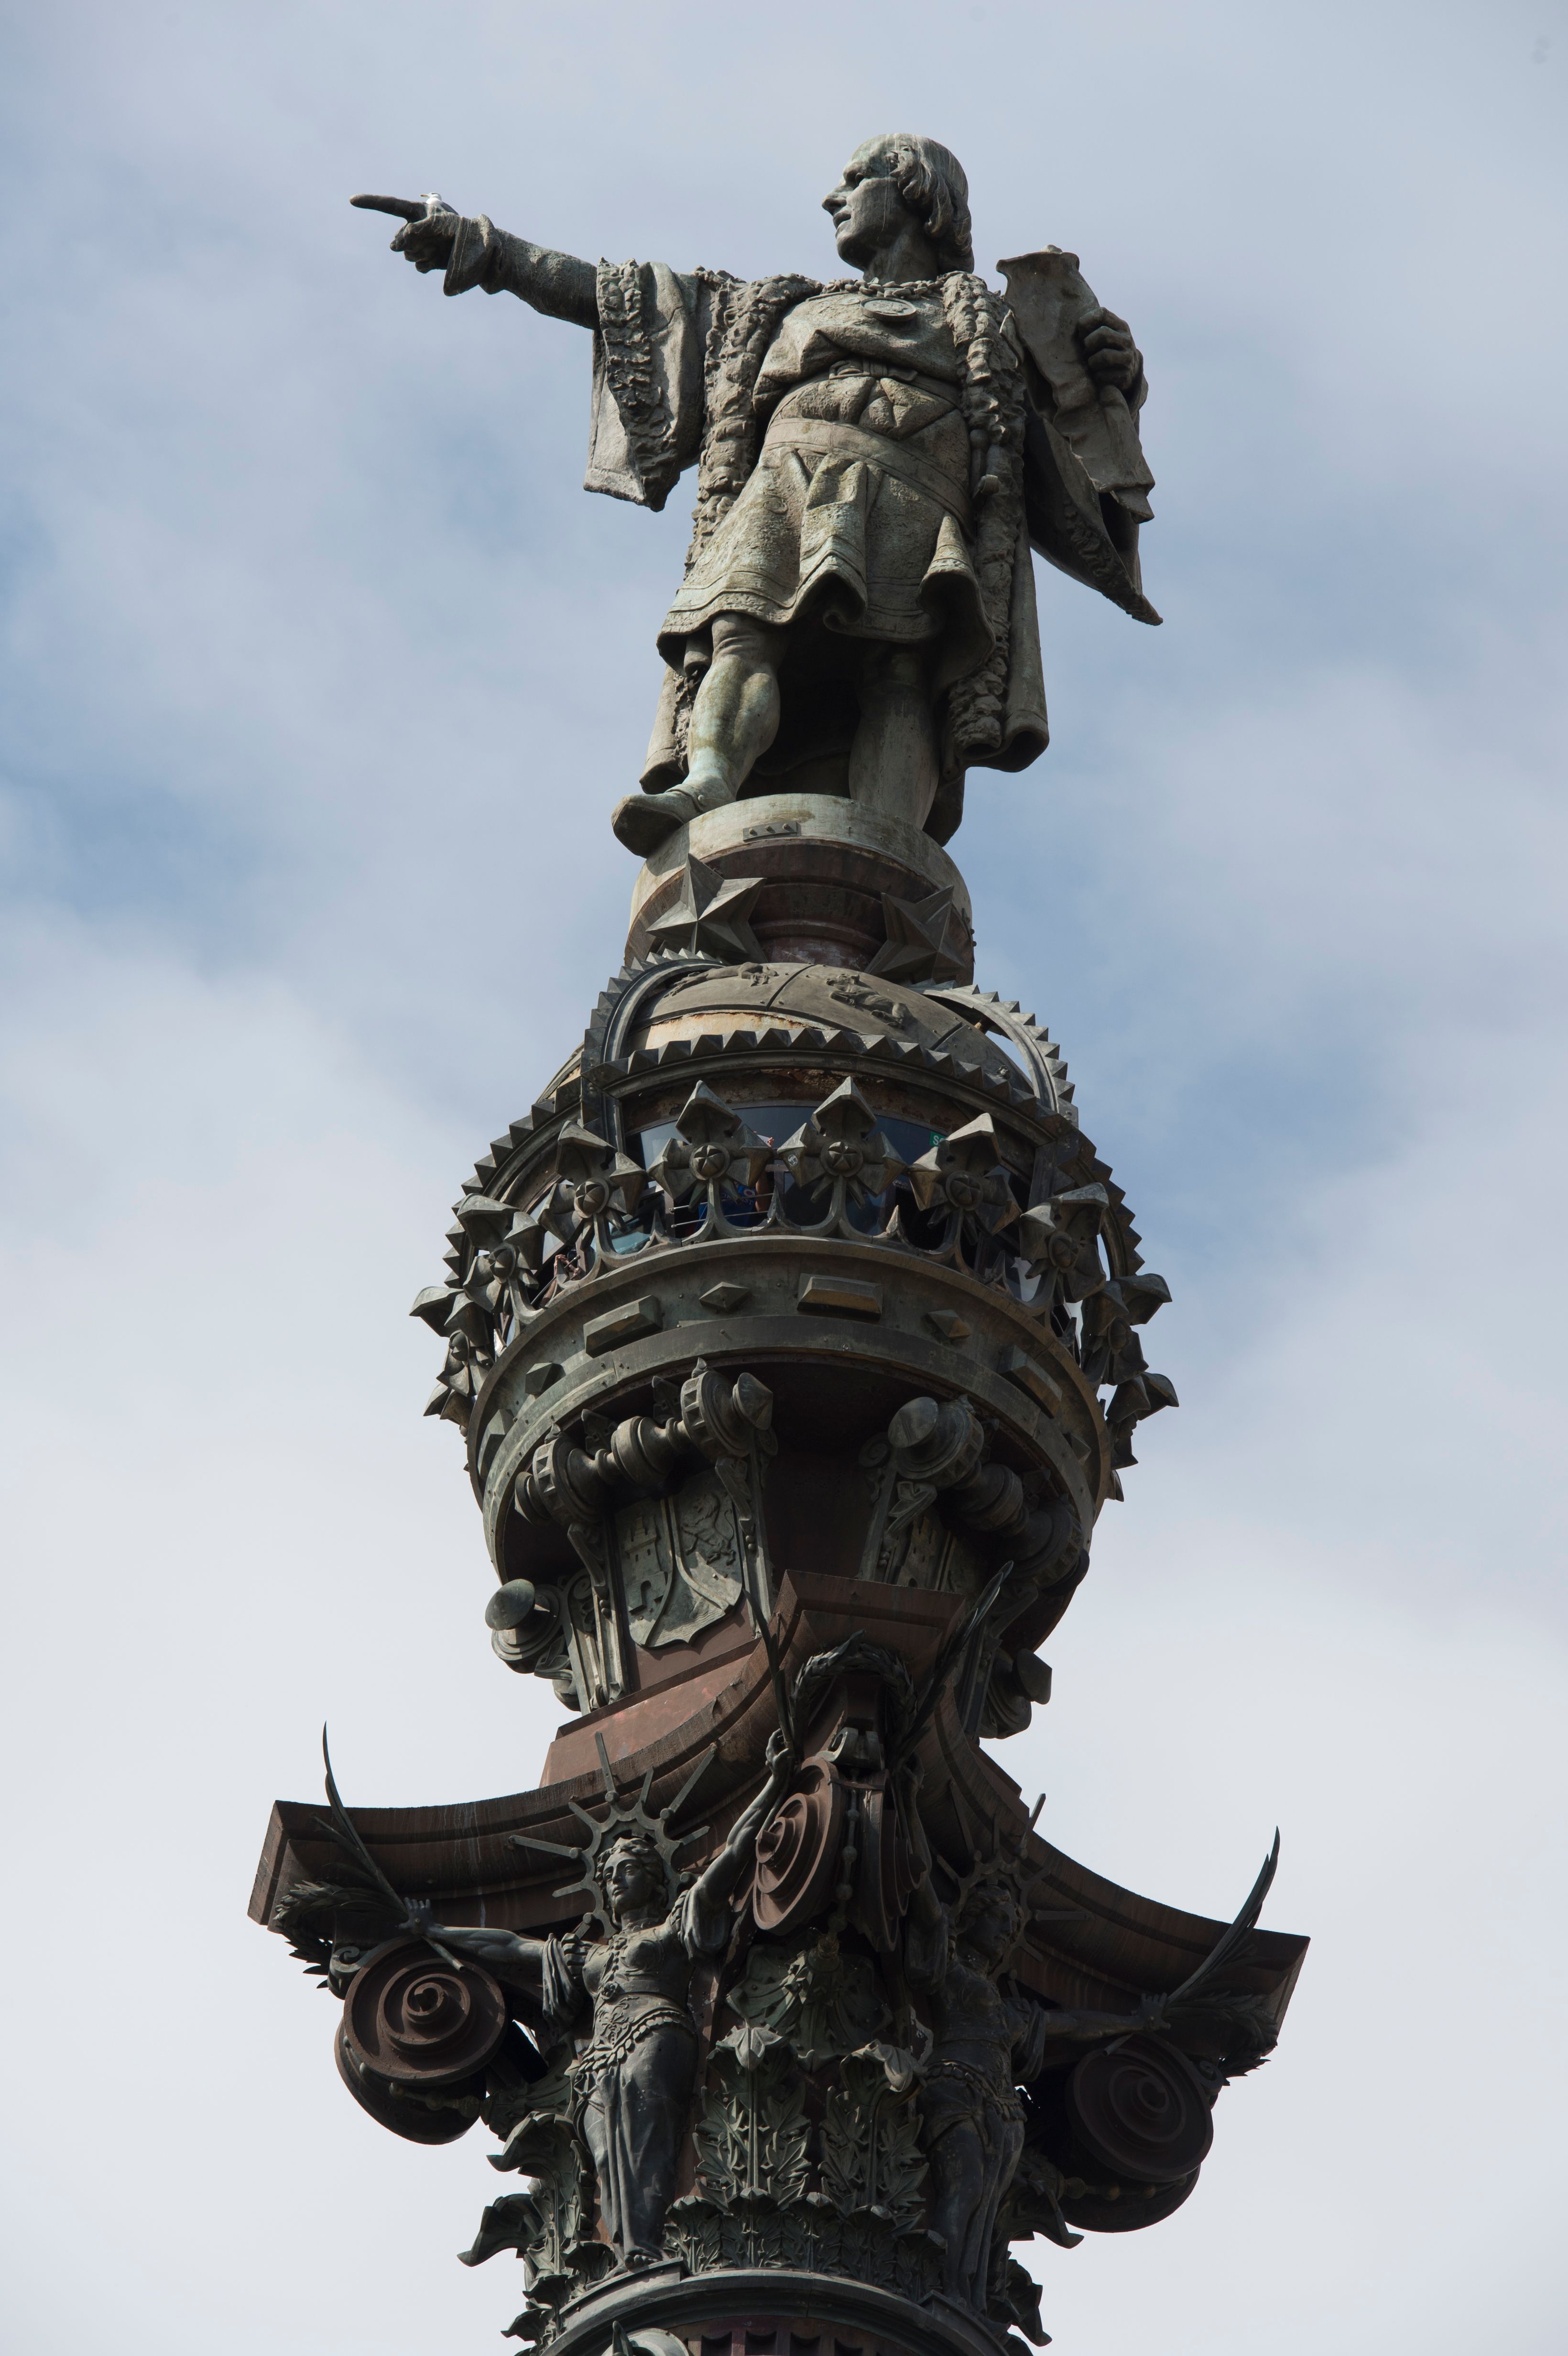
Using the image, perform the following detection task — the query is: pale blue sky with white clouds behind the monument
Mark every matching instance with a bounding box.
[0,0,1568,2356]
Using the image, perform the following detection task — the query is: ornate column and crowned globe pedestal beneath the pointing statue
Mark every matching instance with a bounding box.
[252,794,1304,2356]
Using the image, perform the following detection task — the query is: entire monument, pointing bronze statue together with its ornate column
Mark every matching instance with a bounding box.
[252,139,1307,2356]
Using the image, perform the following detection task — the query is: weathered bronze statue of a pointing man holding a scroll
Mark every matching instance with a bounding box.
[353,132,1158,855]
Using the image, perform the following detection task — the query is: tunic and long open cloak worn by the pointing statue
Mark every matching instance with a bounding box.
[447,219,1158,841]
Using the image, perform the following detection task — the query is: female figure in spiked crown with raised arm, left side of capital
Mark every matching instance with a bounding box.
[410,1734,791,2267]
